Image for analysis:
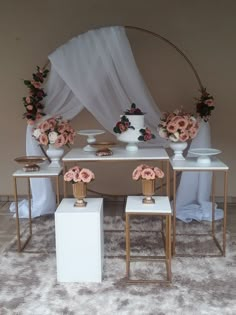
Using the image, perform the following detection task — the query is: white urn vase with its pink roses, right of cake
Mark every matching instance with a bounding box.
[158,109,199,160]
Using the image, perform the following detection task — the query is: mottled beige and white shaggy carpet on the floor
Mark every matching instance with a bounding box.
[0,216,236,315]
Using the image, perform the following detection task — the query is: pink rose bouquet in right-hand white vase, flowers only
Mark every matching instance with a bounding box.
[158,109,199,142]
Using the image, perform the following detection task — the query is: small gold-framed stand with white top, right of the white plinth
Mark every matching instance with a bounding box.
[125,196,172,284]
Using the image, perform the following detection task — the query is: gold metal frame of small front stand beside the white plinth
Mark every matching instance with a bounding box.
[125,212,171,284]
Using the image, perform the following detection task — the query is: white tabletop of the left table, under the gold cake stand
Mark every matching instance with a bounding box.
[12,165,62,177]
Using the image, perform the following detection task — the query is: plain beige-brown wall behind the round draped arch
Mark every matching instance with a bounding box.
[0,0,236,196]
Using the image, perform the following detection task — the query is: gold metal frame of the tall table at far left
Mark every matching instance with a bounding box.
[13,171,62,252]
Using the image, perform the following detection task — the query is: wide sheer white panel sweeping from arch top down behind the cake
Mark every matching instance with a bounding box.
[49,27,166,144]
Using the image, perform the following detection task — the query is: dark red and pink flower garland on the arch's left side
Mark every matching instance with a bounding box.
[23,66,49,125]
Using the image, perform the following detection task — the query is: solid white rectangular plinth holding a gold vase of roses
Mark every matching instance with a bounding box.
[55,198,104,282]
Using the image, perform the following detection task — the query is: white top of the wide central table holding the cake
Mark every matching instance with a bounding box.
[62,147,169,162]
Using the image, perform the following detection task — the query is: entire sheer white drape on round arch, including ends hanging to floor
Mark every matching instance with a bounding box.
[11,27,218,221]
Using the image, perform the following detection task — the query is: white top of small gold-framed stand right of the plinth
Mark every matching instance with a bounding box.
[125,196,172,214]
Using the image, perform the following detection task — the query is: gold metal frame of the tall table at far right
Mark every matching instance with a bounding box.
[172,169,228,257]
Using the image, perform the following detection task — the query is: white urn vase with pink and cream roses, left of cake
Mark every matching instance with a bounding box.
[33,116,76,167]
